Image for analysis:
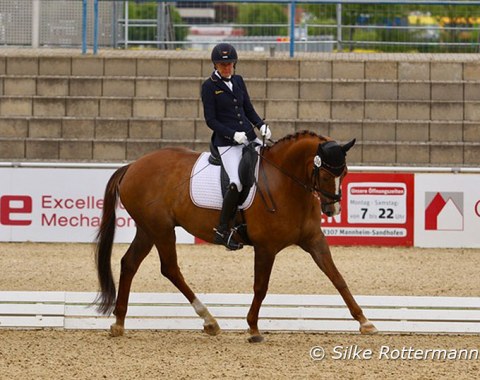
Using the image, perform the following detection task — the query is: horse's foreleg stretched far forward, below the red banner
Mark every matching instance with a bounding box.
[302,234,378,334]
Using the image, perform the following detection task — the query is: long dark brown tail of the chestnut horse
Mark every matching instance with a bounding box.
[95,165,129,314]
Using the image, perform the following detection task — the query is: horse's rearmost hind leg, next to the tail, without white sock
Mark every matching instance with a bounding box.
[110,227,153,336]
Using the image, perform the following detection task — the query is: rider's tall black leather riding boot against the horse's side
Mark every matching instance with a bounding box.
[214,183,243,251]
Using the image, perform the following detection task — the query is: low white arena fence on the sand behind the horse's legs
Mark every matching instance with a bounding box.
[0,291,480,334]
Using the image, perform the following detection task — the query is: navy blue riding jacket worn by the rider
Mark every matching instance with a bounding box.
[202,72,264,146]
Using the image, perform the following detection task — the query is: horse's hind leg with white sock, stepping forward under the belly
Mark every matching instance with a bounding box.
[155,228,220,335]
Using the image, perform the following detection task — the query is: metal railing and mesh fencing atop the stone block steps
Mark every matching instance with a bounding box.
[0,0,480,56]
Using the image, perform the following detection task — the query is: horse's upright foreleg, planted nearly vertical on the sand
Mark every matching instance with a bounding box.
[247,248,275,343]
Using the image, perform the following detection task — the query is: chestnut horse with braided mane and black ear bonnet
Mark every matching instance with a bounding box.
[95,131,377,343]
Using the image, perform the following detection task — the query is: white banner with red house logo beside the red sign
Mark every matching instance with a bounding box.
[414,174,480,248]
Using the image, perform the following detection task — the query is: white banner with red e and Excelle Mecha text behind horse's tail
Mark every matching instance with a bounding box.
[0,168,194,243]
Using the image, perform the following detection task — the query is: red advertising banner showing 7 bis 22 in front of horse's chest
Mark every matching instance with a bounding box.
[322,173,414,246]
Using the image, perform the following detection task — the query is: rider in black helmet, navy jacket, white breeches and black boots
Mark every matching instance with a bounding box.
[202,43,272,250]
